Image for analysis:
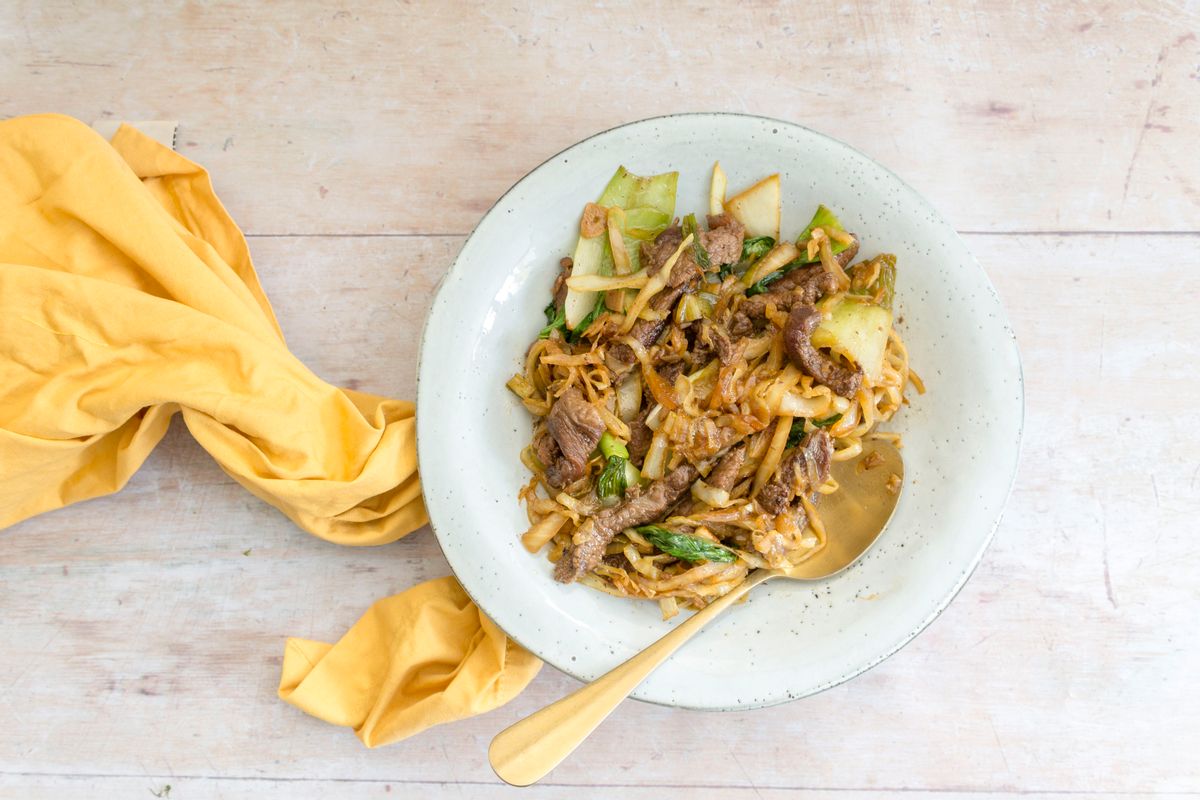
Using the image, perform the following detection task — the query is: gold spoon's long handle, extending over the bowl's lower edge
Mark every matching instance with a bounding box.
[487,570,774,786]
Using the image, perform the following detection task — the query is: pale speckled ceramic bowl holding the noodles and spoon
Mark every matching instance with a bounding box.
[416,114,1024,709]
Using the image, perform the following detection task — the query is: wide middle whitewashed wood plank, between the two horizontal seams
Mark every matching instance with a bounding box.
[0,235,1200,796]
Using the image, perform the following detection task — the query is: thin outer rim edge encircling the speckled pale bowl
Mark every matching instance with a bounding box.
[416,112,1026,711]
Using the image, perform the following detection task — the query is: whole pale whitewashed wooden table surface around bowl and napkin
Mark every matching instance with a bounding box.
[0,0,1200,800]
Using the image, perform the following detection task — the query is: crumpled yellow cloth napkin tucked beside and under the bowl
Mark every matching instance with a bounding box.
[0,115,540,746]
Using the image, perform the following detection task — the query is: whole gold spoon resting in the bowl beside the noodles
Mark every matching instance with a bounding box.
[487,439,904,786]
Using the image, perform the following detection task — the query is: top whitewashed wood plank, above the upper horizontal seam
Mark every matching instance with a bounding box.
[0,0,1200,234]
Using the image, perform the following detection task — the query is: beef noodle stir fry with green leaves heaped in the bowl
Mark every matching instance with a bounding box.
[508,164,924,618]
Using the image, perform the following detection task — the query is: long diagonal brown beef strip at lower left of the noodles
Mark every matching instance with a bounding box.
[554,462,698,583]
